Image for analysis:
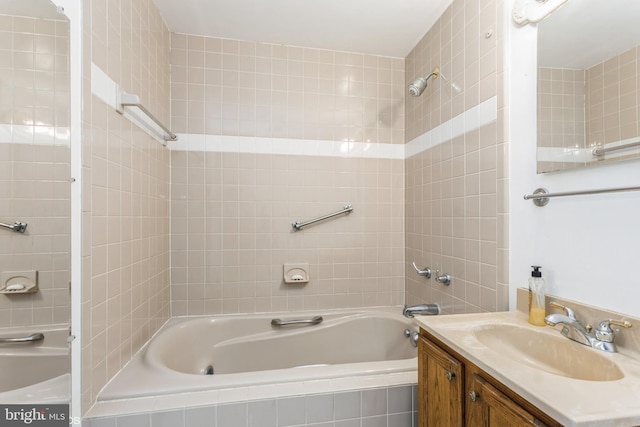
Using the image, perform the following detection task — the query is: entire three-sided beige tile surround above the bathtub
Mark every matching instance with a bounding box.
[77,0,508,422]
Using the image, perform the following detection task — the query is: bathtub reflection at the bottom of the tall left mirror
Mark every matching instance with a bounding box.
[0,325,71,404]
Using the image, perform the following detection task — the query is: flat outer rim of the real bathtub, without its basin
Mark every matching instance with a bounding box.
[90,306,418,418]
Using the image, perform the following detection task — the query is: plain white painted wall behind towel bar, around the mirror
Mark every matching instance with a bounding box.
[506,2,640,316]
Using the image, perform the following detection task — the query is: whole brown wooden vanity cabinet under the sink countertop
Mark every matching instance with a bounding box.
[418,329,561,427]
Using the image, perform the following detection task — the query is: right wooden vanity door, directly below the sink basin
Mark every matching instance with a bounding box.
[466,374,545,427]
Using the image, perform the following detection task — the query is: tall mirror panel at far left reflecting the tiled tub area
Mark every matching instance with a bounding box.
[0,0,71,404]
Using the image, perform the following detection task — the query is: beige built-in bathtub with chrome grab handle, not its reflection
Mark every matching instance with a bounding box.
[98,307,418,402]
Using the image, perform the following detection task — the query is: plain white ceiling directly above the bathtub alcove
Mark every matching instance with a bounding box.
[154,0,451,58]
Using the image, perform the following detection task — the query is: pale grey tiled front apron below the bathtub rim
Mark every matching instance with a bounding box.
[85,385,417,427]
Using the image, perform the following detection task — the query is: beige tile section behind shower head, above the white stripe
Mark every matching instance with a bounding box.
[405,0,501,142]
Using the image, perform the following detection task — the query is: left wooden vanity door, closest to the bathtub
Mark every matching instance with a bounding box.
[418,337,464,427]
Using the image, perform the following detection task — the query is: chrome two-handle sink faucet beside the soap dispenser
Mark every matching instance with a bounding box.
[544,302,631,353]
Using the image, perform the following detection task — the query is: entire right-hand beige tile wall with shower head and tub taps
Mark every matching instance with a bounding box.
[405,0,508,313]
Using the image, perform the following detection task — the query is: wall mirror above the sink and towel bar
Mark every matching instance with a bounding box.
[537,0,640,173]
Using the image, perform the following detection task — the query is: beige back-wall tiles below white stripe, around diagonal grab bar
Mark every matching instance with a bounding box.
[171,152,404,315]
